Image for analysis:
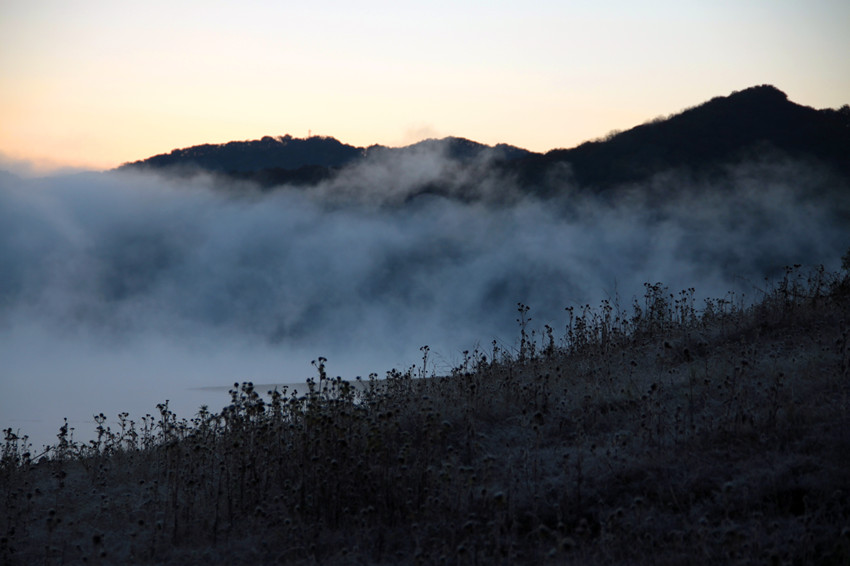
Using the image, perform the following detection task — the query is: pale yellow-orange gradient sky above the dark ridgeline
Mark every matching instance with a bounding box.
[0,0,850,171]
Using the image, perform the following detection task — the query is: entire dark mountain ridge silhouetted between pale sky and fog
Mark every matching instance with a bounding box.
[121,85,850,195]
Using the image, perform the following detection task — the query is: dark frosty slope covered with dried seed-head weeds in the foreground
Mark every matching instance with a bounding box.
[0,269,850,564]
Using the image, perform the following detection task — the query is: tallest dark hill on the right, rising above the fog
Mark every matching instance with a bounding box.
[518,85,850,191]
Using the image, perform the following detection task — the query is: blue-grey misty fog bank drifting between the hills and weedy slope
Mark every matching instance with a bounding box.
[0,148,850,450]
